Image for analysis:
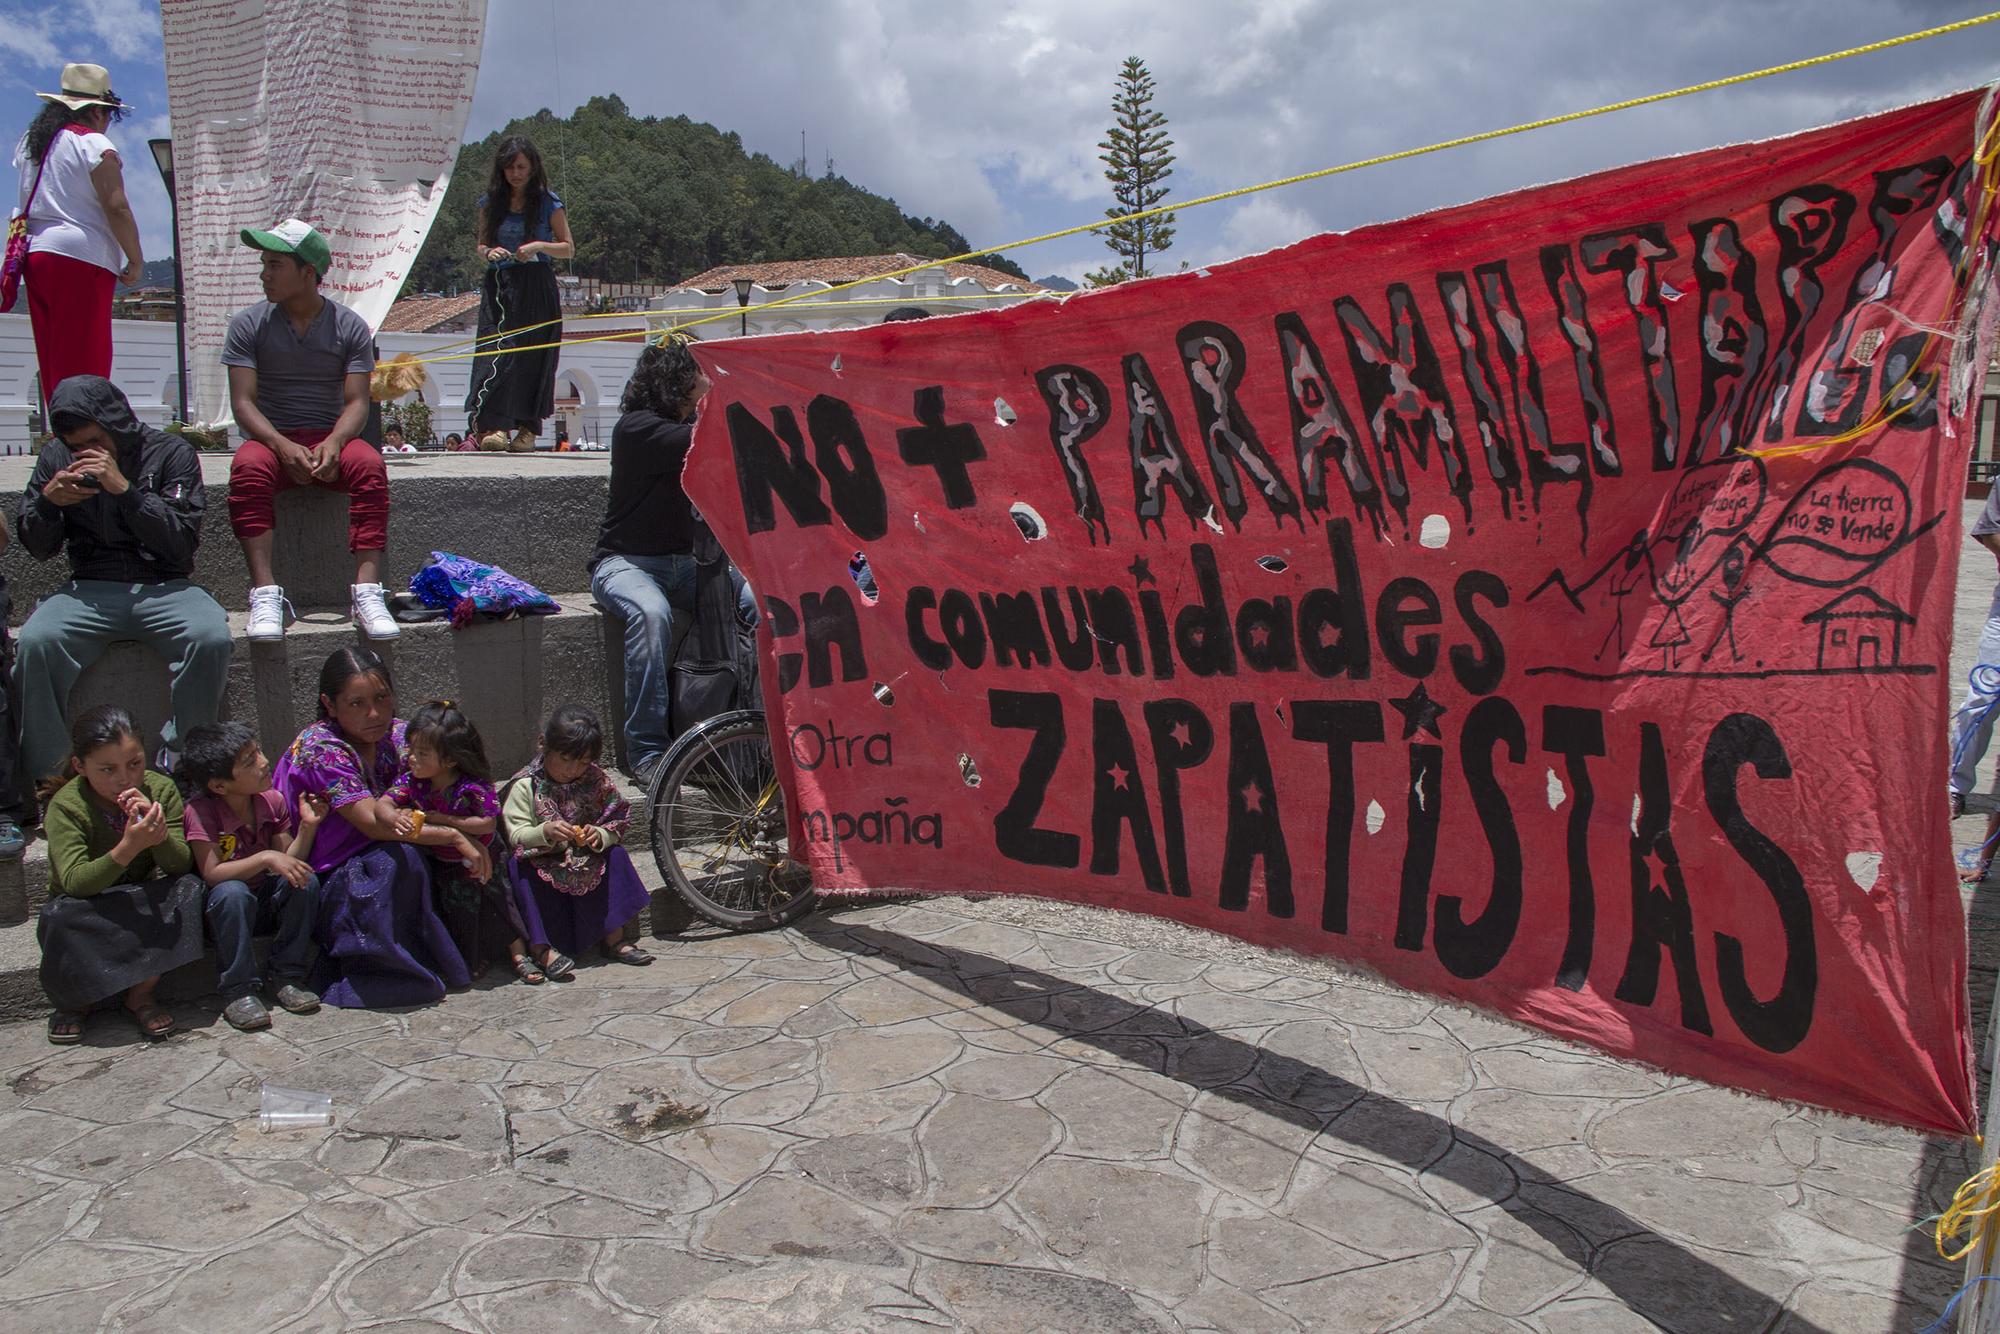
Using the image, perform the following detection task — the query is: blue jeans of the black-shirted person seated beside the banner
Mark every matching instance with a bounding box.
[590,556,758,774]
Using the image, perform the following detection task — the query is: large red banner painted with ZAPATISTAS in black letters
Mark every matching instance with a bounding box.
[688,94,1992,1132]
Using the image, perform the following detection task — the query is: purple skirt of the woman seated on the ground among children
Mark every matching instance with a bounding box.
[312,844,472,1010]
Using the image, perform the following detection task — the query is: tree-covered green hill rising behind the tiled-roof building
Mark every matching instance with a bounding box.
[404,96,1028,294]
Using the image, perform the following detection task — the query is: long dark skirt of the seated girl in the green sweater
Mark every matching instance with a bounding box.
[34,874,204,1010]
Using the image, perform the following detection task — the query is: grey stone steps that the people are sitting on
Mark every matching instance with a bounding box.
[0,454,728,1018]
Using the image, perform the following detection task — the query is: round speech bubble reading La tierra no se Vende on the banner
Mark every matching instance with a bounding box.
[1762,458,1910,588]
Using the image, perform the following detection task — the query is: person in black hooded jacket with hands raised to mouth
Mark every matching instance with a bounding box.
[14,376,230,780]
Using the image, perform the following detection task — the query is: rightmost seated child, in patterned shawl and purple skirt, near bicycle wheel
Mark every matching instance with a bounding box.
[502,704,652,966]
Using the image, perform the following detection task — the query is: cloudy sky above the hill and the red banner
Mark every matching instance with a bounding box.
[11,0,2000,276]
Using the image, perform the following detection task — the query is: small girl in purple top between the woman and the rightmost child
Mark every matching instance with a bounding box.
[380,700,548,986]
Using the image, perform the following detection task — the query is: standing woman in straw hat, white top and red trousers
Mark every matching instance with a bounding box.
[14,64,144,402]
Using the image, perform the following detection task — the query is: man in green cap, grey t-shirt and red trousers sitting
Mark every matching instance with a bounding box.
[222,218,402,640]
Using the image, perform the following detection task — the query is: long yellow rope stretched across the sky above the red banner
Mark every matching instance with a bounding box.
[386,10,2000,370]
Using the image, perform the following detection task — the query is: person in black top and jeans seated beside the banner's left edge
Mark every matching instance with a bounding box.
[590,338,756,784]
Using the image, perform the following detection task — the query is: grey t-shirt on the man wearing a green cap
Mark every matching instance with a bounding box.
[222,300,374,436]
